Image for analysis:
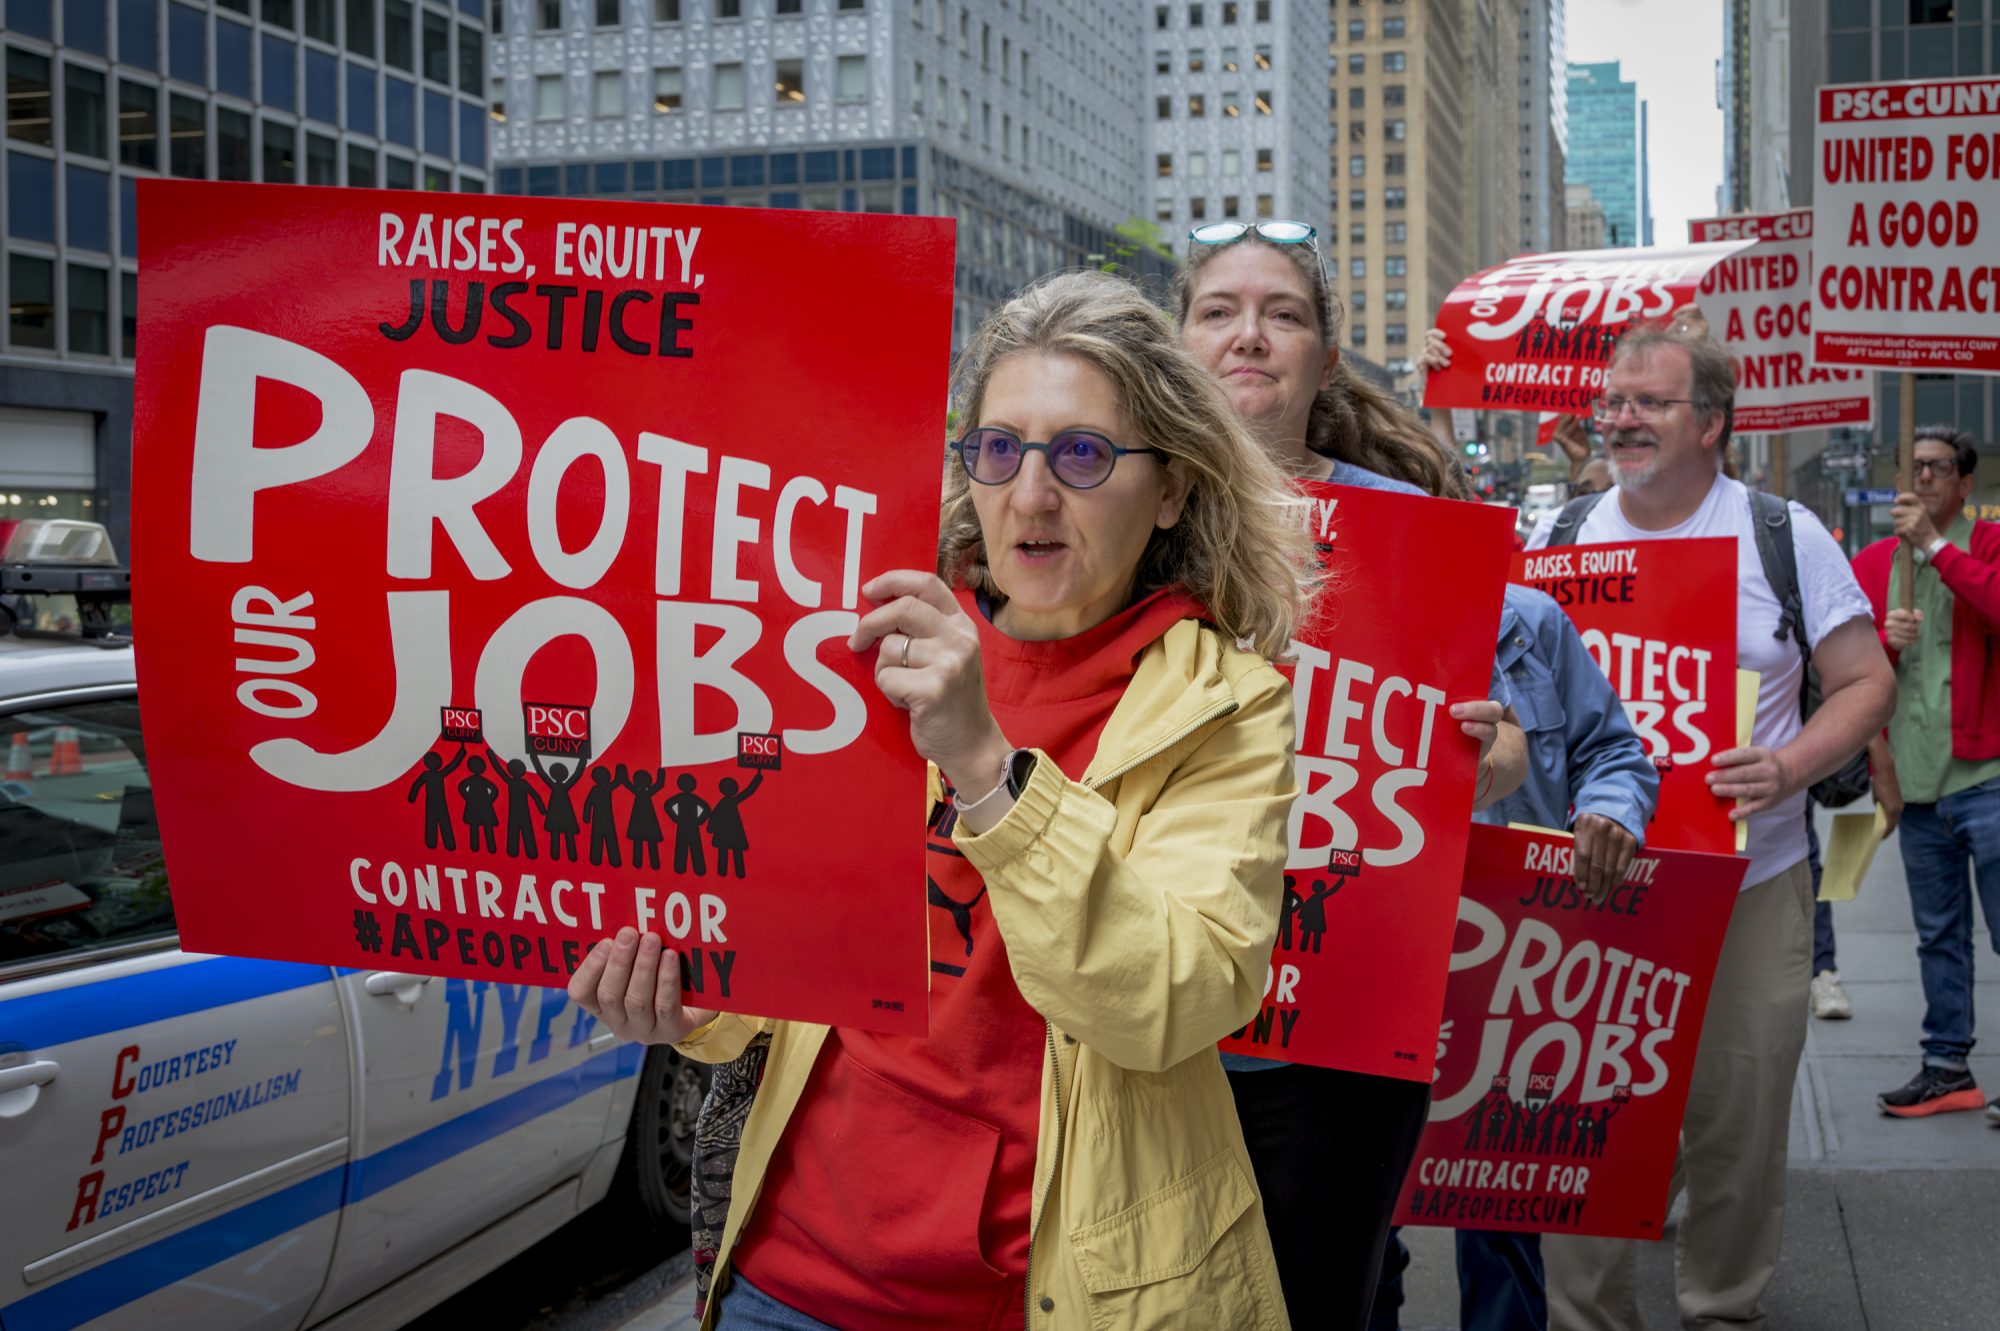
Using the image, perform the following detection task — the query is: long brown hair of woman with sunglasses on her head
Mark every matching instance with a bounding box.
[1168,232,1470,500]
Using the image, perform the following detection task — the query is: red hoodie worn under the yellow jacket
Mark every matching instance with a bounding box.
[734,592,1204,1331]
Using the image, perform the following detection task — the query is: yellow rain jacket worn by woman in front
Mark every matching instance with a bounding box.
[680,620,1296,1331]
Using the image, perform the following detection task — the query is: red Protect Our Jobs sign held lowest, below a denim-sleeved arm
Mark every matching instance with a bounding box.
[1396,825,1748,1239]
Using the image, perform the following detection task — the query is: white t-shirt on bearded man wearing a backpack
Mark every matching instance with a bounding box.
[1528,474,1872,887]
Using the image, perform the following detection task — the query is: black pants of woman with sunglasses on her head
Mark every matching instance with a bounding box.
[1230,1063,1430,1331]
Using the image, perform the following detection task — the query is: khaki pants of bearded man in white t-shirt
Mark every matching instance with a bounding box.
[1542,861,1812,1331]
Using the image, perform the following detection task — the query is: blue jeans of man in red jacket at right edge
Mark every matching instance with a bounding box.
[1900,779,2000,1069]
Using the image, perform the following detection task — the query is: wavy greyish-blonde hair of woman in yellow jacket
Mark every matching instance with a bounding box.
[938,272,1318,660]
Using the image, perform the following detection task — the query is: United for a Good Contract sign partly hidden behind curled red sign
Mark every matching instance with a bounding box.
[1688,208,1874,434]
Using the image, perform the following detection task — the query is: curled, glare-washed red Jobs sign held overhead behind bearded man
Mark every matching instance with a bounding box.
[1424,240,1752,416]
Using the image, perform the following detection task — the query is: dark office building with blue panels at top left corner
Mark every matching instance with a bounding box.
[0,0,488,548]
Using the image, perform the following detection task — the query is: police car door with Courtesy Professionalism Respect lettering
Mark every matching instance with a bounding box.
[0,689,350,1331]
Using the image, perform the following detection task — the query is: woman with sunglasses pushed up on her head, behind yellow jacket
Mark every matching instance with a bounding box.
[1172,222,1526,1331]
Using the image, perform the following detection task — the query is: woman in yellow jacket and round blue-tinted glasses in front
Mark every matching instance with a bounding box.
[570,274,1312,1331]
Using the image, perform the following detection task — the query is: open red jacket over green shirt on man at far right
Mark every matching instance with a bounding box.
[1854,522,2000,761]
